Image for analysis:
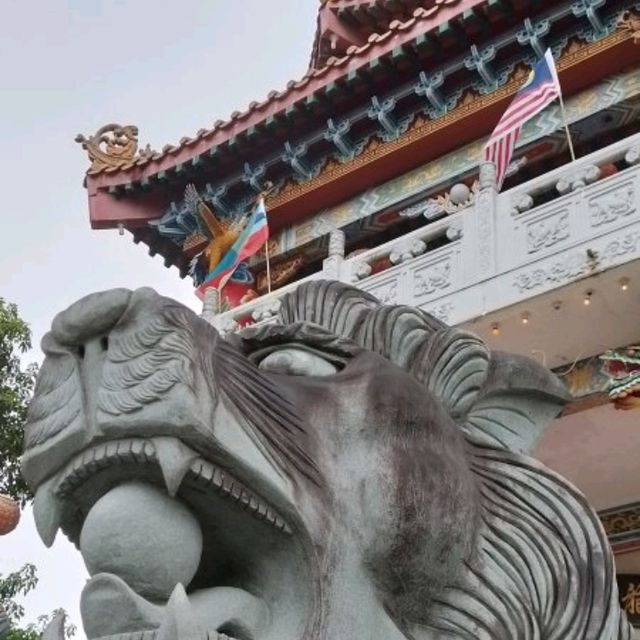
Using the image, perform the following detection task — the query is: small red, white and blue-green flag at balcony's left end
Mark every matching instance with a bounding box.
[196,198,269,298]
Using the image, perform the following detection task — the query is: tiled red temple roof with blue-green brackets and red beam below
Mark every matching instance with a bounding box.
[78,0,640,280]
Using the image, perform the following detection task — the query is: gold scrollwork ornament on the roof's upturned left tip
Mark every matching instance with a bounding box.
[75,124,153,173]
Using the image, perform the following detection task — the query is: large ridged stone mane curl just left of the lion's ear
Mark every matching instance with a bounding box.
[411,328,489,419]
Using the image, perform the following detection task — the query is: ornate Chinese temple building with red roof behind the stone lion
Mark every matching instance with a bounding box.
[77,0,640,624]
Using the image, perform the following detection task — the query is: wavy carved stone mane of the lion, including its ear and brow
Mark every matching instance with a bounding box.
[241,281,632,640]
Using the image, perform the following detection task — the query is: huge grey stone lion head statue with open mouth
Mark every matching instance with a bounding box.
[23,281,631,640]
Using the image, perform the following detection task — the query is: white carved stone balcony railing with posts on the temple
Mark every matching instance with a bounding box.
[211,134,640,332]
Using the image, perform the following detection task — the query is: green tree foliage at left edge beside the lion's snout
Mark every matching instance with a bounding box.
[0,298,37,506]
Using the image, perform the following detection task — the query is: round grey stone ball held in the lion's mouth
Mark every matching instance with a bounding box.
[80,482,202,602]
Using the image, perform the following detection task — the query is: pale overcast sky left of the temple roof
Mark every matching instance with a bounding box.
[0,0,318,638]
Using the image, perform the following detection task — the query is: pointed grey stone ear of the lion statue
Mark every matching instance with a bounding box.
[464,351,570,454]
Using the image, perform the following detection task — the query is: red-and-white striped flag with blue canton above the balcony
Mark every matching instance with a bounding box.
[484,49,561,191]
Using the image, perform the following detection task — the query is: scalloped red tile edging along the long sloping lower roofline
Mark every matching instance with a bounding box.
[86,0,485,196]
